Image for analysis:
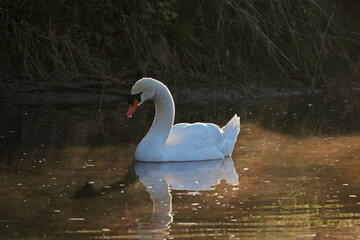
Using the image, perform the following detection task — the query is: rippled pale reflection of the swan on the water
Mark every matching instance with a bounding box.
[135,157,239,235]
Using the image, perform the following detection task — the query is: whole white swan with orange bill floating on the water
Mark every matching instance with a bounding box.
[125,78,240,162]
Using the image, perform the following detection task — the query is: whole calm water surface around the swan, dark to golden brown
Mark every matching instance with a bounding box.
[0,94,360,239]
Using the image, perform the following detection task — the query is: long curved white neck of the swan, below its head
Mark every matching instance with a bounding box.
[143,84,175,148]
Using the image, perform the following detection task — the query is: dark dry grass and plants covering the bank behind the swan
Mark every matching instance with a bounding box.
[0,0,360,96]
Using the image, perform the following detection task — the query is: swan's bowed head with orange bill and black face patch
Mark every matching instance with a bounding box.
[125,78,158,119]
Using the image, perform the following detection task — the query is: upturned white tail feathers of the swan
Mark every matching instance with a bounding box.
[220,114,240,156]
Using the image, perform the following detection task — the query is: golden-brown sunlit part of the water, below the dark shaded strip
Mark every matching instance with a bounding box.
[0,94,360,239]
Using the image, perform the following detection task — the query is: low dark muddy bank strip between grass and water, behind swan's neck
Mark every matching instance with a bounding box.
[0,78,360,108]
